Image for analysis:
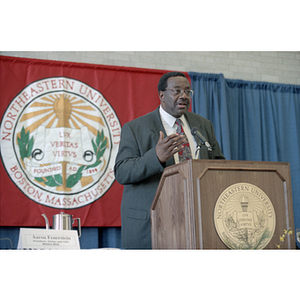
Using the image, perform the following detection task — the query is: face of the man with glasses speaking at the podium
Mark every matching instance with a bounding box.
[159,76,191,118]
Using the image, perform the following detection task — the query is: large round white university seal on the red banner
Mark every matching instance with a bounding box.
[1,77,121,209]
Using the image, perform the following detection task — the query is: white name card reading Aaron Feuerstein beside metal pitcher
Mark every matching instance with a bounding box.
[18,228,80,250]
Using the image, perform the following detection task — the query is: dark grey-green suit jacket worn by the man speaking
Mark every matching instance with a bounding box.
[114,108,225,249]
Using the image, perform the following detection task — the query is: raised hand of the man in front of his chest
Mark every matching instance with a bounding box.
[155,131,186,163]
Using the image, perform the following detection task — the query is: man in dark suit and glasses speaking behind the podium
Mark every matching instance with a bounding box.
[114,72,225,249]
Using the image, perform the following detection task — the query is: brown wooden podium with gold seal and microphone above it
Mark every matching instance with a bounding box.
[151,160,296,249]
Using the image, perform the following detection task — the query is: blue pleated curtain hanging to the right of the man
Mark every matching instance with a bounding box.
[189,72,300,247]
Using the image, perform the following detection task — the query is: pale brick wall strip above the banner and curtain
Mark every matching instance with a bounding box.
[0,51,300,85]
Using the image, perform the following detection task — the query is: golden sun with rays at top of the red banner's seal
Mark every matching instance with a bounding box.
[20,93,105,136]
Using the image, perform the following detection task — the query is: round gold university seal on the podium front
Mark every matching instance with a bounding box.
[214,183,276,249]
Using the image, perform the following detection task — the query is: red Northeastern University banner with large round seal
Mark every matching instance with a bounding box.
[0,56,178,226]
